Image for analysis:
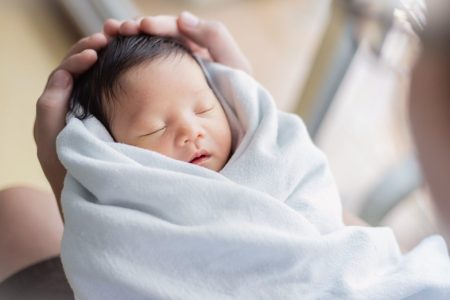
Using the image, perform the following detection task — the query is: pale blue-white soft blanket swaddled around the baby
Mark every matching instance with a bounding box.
[57,59,450,300]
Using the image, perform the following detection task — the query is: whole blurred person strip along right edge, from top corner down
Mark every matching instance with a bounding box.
[409,0,450,243]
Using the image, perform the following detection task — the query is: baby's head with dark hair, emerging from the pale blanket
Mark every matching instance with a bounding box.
[71,35,231,171]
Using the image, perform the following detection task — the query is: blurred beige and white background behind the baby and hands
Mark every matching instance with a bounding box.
[0,0,436,248]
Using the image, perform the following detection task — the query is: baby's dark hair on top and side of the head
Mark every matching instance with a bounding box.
[70,34,192,131]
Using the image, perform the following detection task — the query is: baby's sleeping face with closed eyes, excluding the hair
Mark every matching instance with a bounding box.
[110,55,231,171]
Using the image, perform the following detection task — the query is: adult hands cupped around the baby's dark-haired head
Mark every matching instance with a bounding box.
[34,12,251,218]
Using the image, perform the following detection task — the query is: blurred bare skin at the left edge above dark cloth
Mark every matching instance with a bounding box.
[0,187,63,282]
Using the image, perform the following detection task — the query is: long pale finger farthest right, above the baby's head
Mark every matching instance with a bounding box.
[177,12,251,73]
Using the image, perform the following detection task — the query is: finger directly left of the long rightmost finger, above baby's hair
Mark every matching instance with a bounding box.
[139,15,180,38]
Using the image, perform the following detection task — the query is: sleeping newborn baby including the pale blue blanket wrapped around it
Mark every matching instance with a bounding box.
[57,35,450,299]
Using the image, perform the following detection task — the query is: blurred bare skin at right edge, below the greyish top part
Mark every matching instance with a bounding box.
[409,47,450,243]
